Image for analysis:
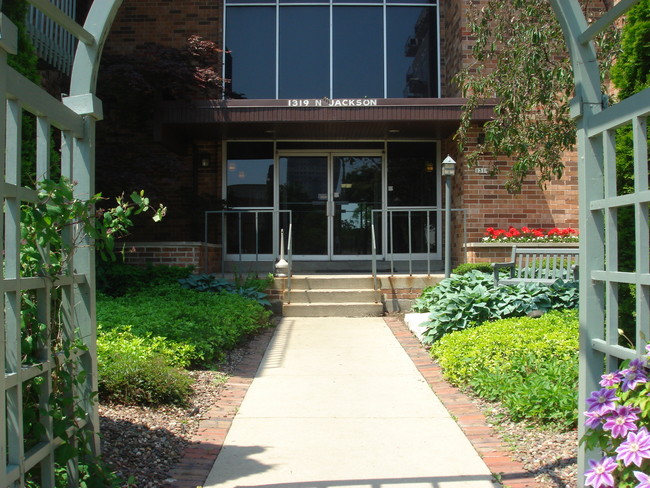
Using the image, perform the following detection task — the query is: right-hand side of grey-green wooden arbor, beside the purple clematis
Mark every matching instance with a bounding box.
[551,0,650,486]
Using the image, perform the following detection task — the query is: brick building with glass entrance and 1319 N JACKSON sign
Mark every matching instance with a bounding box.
[90,0,578,272]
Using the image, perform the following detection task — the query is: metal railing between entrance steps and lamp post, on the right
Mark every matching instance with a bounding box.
[371,207,467,280]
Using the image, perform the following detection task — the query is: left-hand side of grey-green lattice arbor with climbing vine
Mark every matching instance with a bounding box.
[0,0,121,488]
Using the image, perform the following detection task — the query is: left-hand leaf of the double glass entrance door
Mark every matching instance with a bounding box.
[279,156,329,256]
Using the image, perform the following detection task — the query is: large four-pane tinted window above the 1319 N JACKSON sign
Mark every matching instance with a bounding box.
[224,0,439,98]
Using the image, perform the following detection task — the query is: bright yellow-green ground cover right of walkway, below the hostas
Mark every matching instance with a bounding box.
[431,310,578,428]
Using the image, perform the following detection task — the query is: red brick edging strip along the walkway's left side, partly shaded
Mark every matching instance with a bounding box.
[170,327,276,488]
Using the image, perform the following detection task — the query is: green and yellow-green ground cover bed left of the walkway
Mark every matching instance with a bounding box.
[97,263,270,405]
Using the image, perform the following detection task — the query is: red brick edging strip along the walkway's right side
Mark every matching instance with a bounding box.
[384,317,542,488]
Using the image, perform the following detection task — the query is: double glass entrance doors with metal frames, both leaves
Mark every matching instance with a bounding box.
[278,153,382,259]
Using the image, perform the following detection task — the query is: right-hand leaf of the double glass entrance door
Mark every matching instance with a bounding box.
[332,156,381,255]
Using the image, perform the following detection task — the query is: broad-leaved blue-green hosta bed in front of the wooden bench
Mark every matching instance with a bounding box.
[413,271,578,344]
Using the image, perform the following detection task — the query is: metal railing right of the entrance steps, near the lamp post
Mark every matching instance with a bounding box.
[371,207,467,287]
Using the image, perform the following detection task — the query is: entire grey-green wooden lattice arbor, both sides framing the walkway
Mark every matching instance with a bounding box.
[0,0,650,488]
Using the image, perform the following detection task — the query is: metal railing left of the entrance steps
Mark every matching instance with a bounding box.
[204,209,292,276]
